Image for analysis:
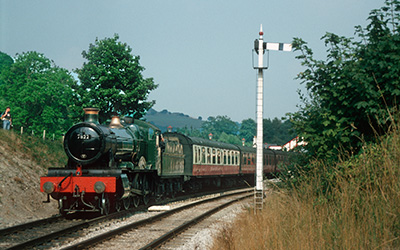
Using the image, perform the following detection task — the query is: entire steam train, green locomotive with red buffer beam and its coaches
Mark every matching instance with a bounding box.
[40,108,287,215]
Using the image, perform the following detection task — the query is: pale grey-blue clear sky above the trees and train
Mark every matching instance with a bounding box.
[0,0,384,122]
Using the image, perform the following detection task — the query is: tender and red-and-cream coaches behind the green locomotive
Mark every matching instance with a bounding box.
[161,132,287,186]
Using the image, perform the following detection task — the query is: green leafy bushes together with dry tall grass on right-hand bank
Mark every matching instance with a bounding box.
[213,0,400,249]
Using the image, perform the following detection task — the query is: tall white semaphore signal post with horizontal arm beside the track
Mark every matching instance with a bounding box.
[253,25,292,212]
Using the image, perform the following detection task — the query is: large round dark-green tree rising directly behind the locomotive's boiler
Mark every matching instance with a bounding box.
[74,34,157,121]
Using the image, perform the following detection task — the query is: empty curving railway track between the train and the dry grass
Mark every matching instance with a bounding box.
[62,189,253,250]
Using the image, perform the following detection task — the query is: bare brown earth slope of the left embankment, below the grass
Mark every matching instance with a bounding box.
[0,144,58,228]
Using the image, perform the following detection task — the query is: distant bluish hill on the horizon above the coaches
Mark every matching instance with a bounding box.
[144,109,203,132]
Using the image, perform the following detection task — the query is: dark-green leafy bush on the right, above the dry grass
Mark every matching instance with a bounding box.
[290,0,400,159]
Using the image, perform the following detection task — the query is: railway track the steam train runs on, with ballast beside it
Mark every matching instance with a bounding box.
[0,189,252,249]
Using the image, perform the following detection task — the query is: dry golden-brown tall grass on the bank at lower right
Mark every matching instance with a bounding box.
[212,125,400,249]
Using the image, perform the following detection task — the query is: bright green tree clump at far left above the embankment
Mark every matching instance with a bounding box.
[0,52,74,136]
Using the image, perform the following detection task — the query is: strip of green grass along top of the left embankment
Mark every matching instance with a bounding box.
[0,129,67,169]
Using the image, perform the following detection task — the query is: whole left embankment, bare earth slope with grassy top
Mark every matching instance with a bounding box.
[0,129,60,228]
